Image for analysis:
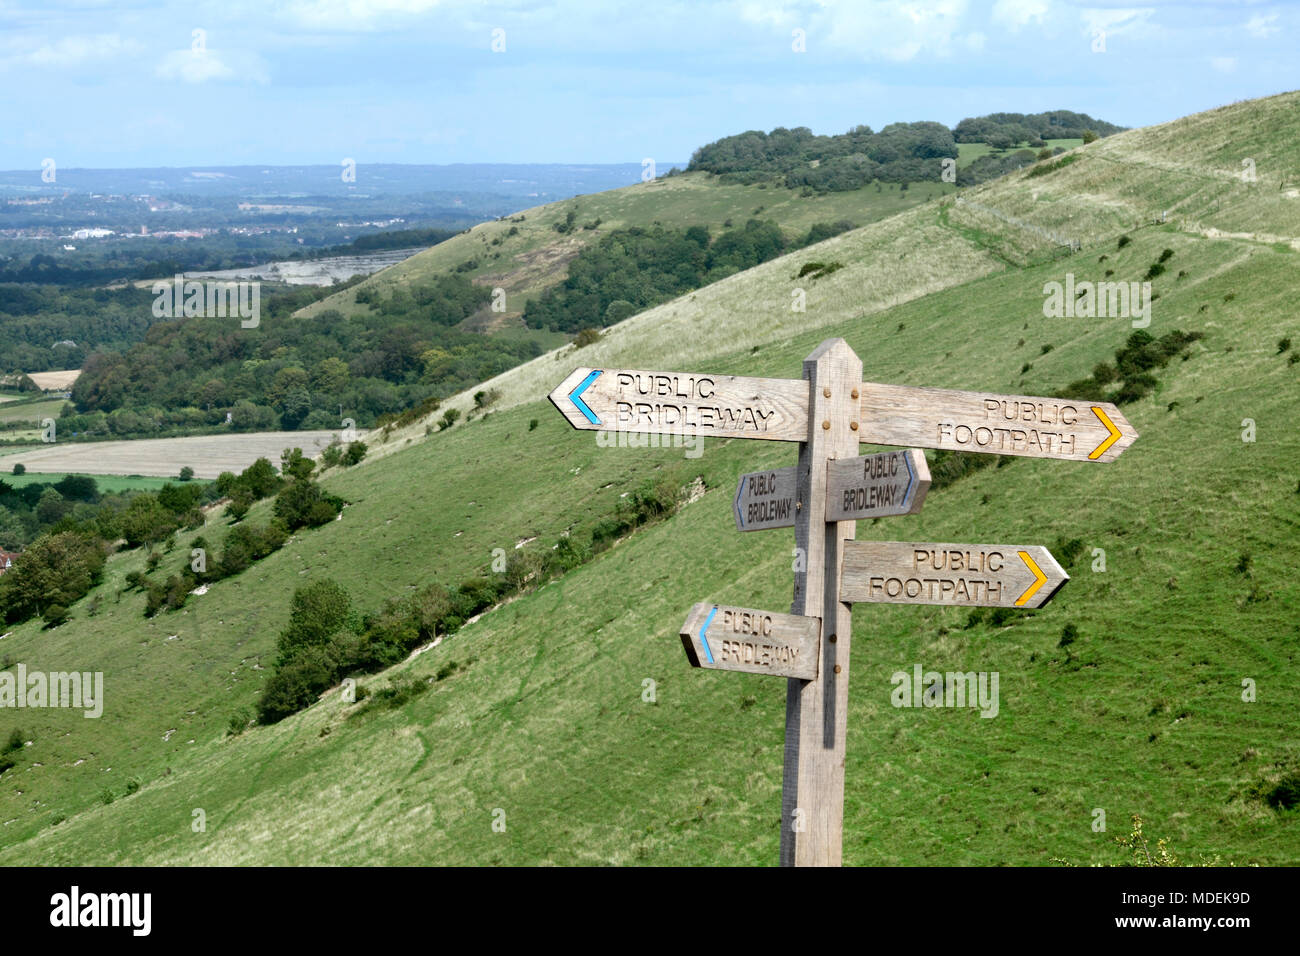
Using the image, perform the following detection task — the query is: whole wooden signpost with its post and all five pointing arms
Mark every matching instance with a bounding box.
[550,338,1138,866]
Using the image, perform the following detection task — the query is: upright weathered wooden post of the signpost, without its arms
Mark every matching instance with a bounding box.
[781,338,862,866]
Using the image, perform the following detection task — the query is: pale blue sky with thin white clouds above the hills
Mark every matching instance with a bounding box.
[0,0,1300,170]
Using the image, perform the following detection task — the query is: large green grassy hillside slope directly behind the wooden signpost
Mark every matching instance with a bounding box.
[0,94,1300,865]
